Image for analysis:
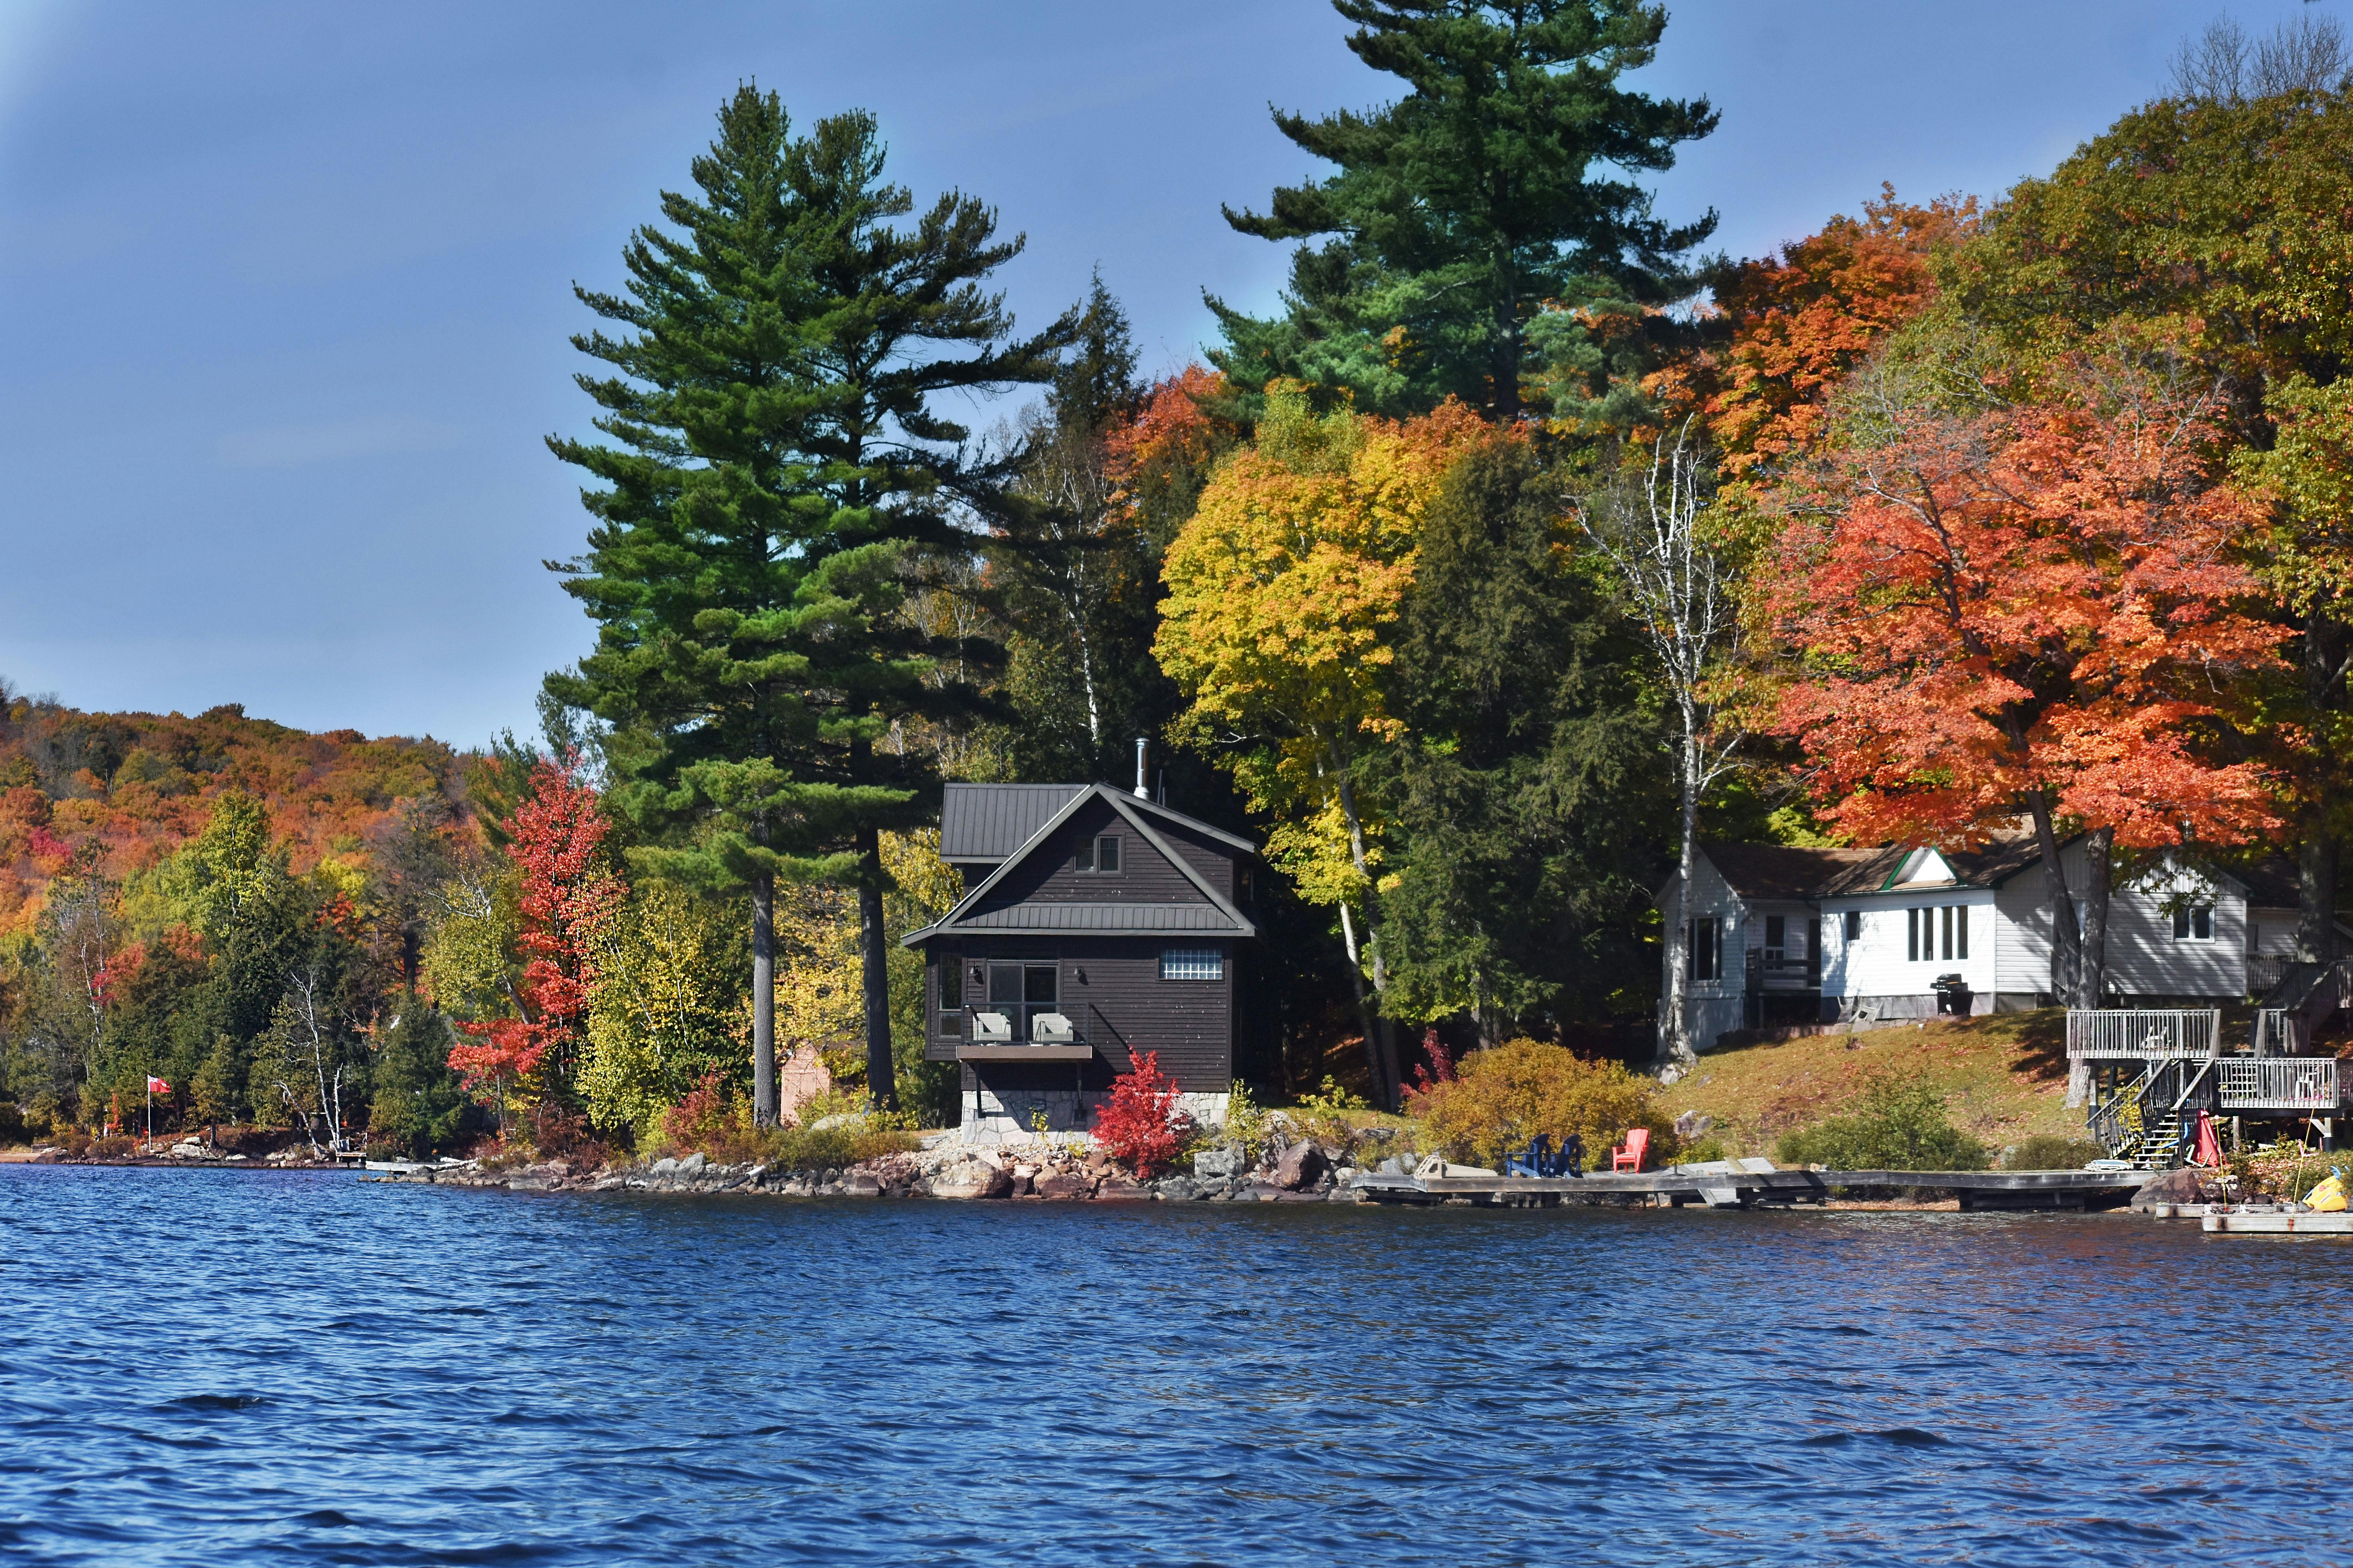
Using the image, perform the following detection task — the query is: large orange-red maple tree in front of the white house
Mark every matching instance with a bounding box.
[1767,383,2282,994]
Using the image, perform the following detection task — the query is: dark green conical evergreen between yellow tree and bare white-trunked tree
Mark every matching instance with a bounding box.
[1379,440,1673,1044]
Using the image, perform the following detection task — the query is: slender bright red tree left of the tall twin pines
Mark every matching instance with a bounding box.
[449,762,626,1103]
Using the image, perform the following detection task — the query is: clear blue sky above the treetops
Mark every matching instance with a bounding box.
[0,0,2301,745]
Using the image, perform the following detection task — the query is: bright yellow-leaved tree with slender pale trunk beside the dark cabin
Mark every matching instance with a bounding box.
[1153,383,1490,1105]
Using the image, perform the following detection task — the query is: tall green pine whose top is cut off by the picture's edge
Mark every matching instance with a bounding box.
[1209,0,1715,419]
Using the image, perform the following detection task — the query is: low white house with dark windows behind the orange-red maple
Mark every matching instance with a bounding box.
[1659,834,2353,1051]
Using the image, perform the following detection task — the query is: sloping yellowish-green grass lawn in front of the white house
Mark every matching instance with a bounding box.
[1661,1009,2085,1159]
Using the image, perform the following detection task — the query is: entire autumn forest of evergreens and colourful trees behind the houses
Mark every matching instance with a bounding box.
[0,0,2353,1154]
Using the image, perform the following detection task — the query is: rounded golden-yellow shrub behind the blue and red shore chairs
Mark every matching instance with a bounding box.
[1412,1039,1675,1168]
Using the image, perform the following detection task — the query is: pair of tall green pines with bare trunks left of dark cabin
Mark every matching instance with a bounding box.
[548,85,1071,1121]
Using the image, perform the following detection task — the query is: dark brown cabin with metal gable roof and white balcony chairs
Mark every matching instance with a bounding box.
[906,785,1259,1143]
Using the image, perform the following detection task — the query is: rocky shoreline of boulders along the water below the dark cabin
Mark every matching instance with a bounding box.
[367,1143,1360,1204]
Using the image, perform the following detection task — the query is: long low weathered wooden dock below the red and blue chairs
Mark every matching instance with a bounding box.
[1350,1159,2155,1211]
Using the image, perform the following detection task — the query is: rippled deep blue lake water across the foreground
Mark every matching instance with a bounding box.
[0,1166,2353,1568]
